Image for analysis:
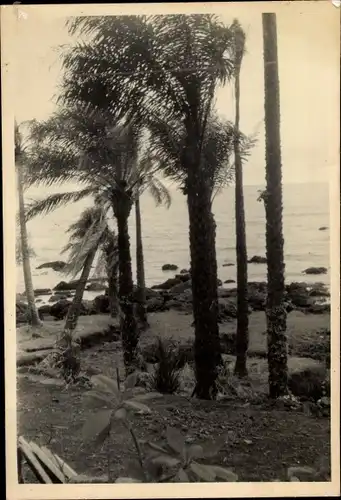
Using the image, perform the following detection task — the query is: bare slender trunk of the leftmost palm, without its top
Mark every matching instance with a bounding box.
[17,165,42,326]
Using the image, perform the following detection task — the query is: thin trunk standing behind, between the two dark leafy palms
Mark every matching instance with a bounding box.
[135,198,148,327]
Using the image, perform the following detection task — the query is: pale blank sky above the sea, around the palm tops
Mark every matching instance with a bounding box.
[11,1,340,185]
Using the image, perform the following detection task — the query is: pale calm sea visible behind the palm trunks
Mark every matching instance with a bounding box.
[17,183,330,298]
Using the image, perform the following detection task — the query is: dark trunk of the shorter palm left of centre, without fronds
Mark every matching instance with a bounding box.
[113,192,139,375]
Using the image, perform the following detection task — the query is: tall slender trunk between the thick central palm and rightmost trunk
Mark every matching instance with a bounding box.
[234,55,249,377]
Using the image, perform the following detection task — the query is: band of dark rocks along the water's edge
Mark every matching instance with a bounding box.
[16,268,330,324]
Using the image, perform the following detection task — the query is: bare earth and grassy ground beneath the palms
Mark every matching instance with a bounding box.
[17,312,330,481]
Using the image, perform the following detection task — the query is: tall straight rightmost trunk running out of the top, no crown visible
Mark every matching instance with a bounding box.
[262,14,288,398]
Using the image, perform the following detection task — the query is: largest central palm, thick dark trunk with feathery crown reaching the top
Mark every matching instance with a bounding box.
[61,15,242,399]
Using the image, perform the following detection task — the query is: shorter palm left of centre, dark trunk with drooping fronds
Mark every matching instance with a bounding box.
[27,104,170,369]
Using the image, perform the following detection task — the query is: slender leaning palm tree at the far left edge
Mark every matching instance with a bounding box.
[14,124,42,326]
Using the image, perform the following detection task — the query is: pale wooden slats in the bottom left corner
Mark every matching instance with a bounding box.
[17,436,78,484]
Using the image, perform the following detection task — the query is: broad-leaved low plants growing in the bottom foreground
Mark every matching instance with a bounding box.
[75,373,238,483]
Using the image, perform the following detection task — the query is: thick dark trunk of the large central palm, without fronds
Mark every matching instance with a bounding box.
[187,165,222,399]
